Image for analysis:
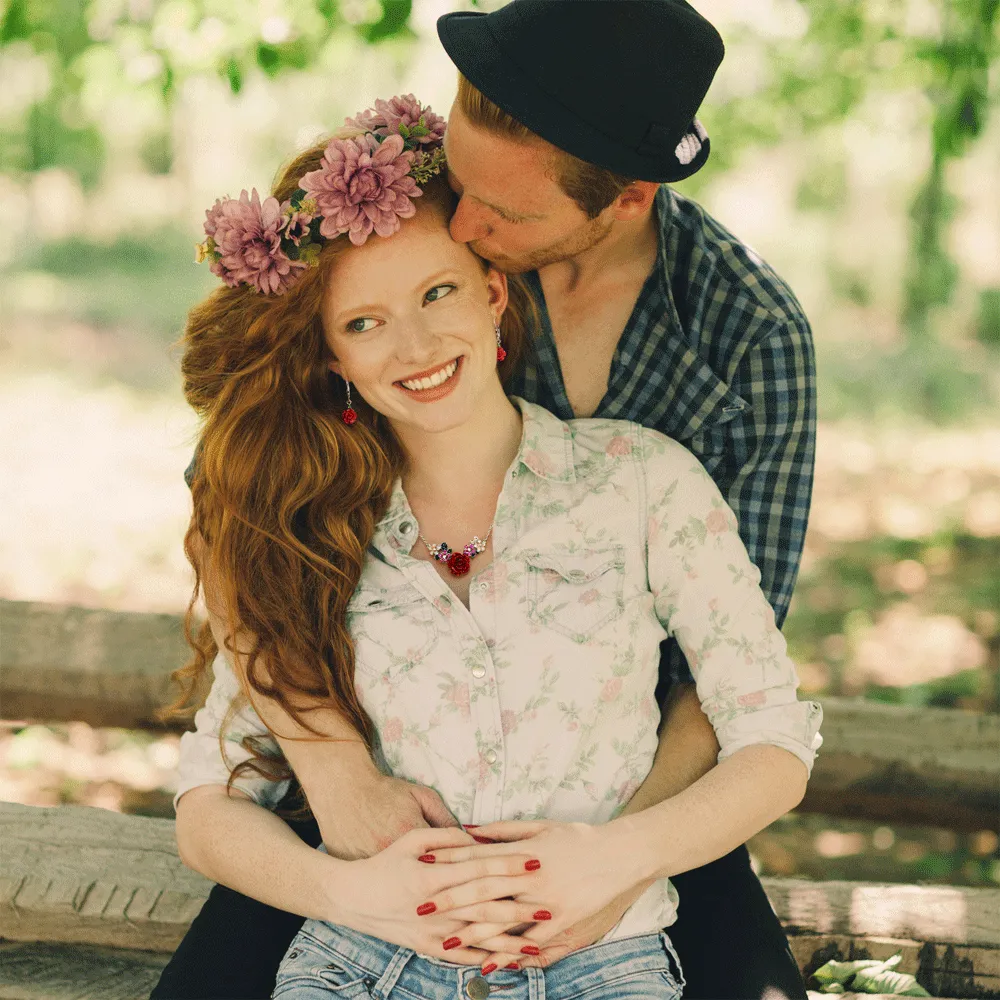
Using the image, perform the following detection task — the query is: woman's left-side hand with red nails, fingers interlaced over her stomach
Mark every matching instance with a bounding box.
[329,827,556,965]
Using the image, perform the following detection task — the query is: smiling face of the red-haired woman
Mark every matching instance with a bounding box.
[322,205,507,431]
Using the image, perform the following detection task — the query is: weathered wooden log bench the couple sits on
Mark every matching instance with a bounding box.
[0,601,1000,1000]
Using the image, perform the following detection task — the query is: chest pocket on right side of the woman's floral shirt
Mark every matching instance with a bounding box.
[524,545,625,643]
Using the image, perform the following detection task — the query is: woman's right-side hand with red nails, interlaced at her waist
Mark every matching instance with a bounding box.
[426,820,652,969]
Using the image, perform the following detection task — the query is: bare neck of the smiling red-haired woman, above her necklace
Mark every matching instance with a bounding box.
[395,382,521,503]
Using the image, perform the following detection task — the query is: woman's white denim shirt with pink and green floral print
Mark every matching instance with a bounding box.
[175,399,822,939]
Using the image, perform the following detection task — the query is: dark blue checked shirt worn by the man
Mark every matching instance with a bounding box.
[510,187,816,701]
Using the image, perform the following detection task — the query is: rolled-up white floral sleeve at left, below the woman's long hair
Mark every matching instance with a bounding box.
[174,653,291,810]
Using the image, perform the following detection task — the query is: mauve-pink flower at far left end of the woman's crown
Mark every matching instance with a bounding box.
[205,188,307,295]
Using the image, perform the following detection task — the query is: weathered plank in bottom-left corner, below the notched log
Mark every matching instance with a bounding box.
[0,942,168,1000]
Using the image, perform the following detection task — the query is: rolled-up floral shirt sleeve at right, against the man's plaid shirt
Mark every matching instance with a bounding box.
[643,430,823,771]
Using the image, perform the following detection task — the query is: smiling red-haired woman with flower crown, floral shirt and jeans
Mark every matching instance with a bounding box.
[178,99,819,997]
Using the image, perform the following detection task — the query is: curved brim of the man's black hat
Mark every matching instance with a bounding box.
[437,11,711,182]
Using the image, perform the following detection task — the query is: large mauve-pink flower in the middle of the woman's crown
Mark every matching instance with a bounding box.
[299,135,422,246]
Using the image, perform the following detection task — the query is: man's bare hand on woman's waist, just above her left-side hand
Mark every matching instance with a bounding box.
[318,772,459,861]
